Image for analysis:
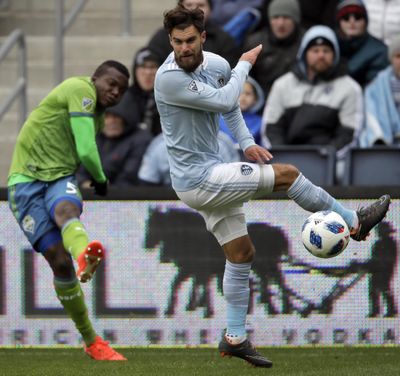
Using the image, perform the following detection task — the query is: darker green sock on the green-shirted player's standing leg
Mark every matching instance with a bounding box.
[54,279,97,346]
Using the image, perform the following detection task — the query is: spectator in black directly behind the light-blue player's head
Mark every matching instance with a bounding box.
[148,0,242,67]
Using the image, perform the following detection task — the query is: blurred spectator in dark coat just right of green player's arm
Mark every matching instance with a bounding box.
[77,94,152,188]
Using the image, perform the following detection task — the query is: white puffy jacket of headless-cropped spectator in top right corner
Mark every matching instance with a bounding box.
[364,0,400,46]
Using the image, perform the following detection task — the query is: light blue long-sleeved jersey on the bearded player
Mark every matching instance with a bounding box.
[154,52,255,192]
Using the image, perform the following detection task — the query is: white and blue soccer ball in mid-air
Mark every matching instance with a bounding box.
[301,210,350,258]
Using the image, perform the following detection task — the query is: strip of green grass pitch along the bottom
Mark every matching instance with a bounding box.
[0,346,400,376]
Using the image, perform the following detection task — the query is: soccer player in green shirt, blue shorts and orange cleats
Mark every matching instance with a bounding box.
[8,60,129,360]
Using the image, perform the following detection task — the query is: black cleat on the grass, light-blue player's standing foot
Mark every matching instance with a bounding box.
[218,336,272,368]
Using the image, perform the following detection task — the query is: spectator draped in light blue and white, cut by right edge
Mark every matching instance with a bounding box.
[360,35,400,147]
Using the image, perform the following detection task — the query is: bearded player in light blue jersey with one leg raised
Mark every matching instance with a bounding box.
[155,6,390,367]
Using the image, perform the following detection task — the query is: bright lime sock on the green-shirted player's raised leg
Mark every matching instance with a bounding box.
[61,218,89,260]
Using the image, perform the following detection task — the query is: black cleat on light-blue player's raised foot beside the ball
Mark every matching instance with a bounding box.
[350,195,390,241]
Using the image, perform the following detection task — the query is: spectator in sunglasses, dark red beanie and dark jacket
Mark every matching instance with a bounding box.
[336,0,389,87]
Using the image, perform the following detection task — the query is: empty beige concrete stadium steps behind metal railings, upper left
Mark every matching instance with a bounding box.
[0,0,176,187]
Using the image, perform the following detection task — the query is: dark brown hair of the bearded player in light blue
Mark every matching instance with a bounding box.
[164,5,205,34]
